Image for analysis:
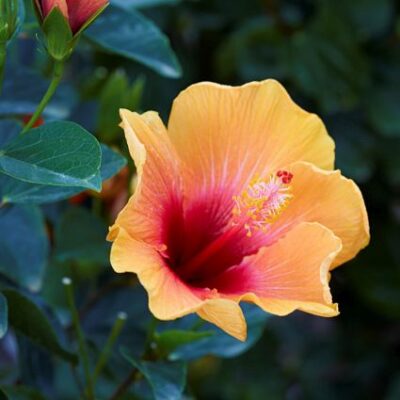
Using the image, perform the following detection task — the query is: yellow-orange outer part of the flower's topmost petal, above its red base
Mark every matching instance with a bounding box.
[168,80,334,198]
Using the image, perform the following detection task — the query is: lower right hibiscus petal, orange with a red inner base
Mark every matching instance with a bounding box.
[208,223,342,317]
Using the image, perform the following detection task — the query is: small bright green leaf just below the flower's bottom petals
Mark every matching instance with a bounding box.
[155,329,215,354]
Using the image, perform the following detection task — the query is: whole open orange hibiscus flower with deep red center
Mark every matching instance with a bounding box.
[109,80,369,340]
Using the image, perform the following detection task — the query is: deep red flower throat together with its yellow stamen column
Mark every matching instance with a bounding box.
[165,171,293,289]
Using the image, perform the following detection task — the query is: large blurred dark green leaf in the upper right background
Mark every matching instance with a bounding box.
[286,2,371,113]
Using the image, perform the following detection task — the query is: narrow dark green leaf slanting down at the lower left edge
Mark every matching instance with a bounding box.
[3,289,78,364]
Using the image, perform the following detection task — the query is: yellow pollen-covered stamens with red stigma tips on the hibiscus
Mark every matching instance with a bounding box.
[232,170,293,236]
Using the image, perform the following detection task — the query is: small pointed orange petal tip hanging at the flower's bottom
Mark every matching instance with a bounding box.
[197,299,247,341]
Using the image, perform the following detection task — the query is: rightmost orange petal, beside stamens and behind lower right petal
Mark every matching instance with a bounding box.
[272,163,370,267]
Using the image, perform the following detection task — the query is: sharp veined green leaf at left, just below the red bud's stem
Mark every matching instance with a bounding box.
[0,122,101,190]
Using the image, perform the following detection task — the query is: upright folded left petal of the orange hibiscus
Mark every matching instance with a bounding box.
[109,110,182,249]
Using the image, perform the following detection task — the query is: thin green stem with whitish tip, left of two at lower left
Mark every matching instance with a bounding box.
[62,277,95,400]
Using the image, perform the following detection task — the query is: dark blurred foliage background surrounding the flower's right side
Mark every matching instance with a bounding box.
[130,0,400,400]
